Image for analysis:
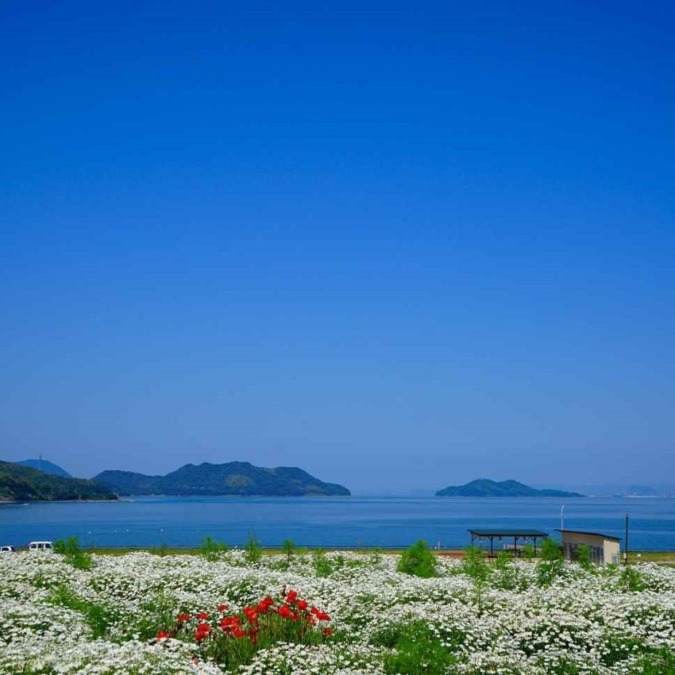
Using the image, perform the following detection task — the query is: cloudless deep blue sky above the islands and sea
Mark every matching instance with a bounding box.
[0,0,675,493]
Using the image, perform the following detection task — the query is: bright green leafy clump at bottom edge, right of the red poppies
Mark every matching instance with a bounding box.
[372,621,456,675]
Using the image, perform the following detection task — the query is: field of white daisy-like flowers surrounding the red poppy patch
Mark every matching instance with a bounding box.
[0,551,675,675]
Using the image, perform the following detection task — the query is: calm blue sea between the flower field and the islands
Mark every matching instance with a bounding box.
[0,497,675,550]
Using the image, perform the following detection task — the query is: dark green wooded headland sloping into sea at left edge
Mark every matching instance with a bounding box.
[0,461,117,502]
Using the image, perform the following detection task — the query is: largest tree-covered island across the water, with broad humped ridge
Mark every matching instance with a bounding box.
[94,462,351,497]
